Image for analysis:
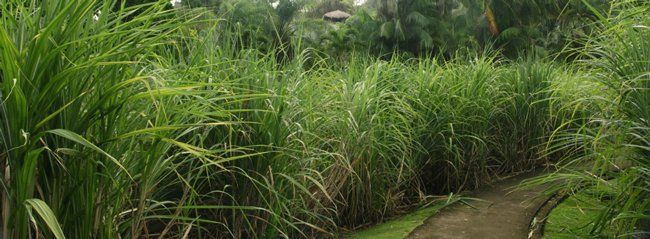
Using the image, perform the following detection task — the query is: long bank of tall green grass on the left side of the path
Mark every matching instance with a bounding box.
[0,0,628,238]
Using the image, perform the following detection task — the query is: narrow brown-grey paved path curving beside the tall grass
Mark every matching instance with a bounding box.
[407,173,546,239]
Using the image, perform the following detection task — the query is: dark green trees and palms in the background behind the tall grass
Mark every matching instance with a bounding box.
[180,0,609,58]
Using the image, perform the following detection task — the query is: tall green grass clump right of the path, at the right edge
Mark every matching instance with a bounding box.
[524,0,650,238]
